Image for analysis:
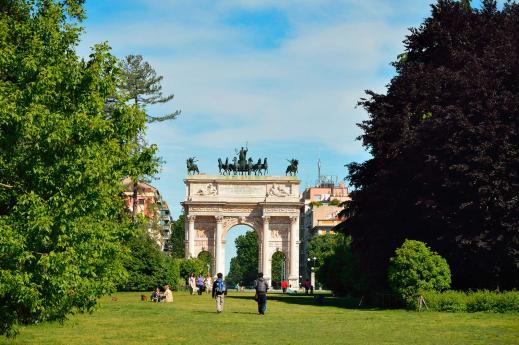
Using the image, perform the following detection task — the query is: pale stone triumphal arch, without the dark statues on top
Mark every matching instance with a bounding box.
[182,174,302,287]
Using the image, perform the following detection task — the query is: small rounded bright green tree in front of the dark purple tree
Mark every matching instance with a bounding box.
[388,240,451,301]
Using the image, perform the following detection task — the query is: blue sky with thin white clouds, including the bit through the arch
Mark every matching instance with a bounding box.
[78,0,496,272]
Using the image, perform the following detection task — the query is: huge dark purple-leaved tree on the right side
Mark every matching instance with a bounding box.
[341,0,519,289]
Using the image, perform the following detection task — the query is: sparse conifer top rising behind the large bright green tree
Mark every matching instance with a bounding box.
[119,55,180,122]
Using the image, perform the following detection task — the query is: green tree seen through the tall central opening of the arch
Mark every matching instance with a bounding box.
[226,231,258,285]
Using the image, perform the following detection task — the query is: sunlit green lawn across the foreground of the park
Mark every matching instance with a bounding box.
[0,292,519,345]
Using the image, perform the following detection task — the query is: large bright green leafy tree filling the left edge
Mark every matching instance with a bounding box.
[0,0,157,335]
